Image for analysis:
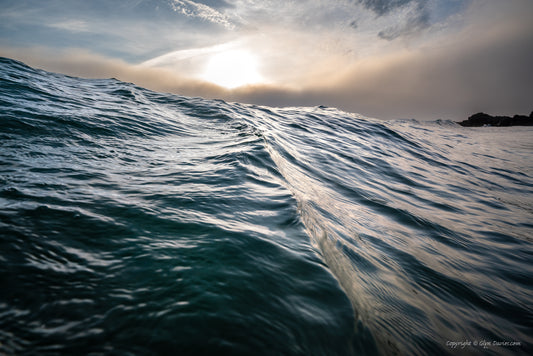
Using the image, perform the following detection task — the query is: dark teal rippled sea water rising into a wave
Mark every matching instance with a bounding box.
[0,58,533,355]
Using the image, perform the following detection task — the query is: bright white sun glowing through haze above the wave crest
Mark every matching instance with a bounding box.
[202,50,263,89]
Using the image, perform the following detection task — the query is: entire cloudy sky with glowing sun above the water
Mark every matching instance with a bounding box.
[0,0,533,121]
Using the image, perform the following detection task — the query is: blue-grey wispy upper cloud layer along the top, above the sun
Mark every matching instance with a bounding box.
[0,0,467,67]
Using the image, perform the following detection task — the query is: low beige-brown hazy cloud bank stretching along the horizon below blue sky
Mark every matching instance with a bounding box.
[0,0,533,120]
